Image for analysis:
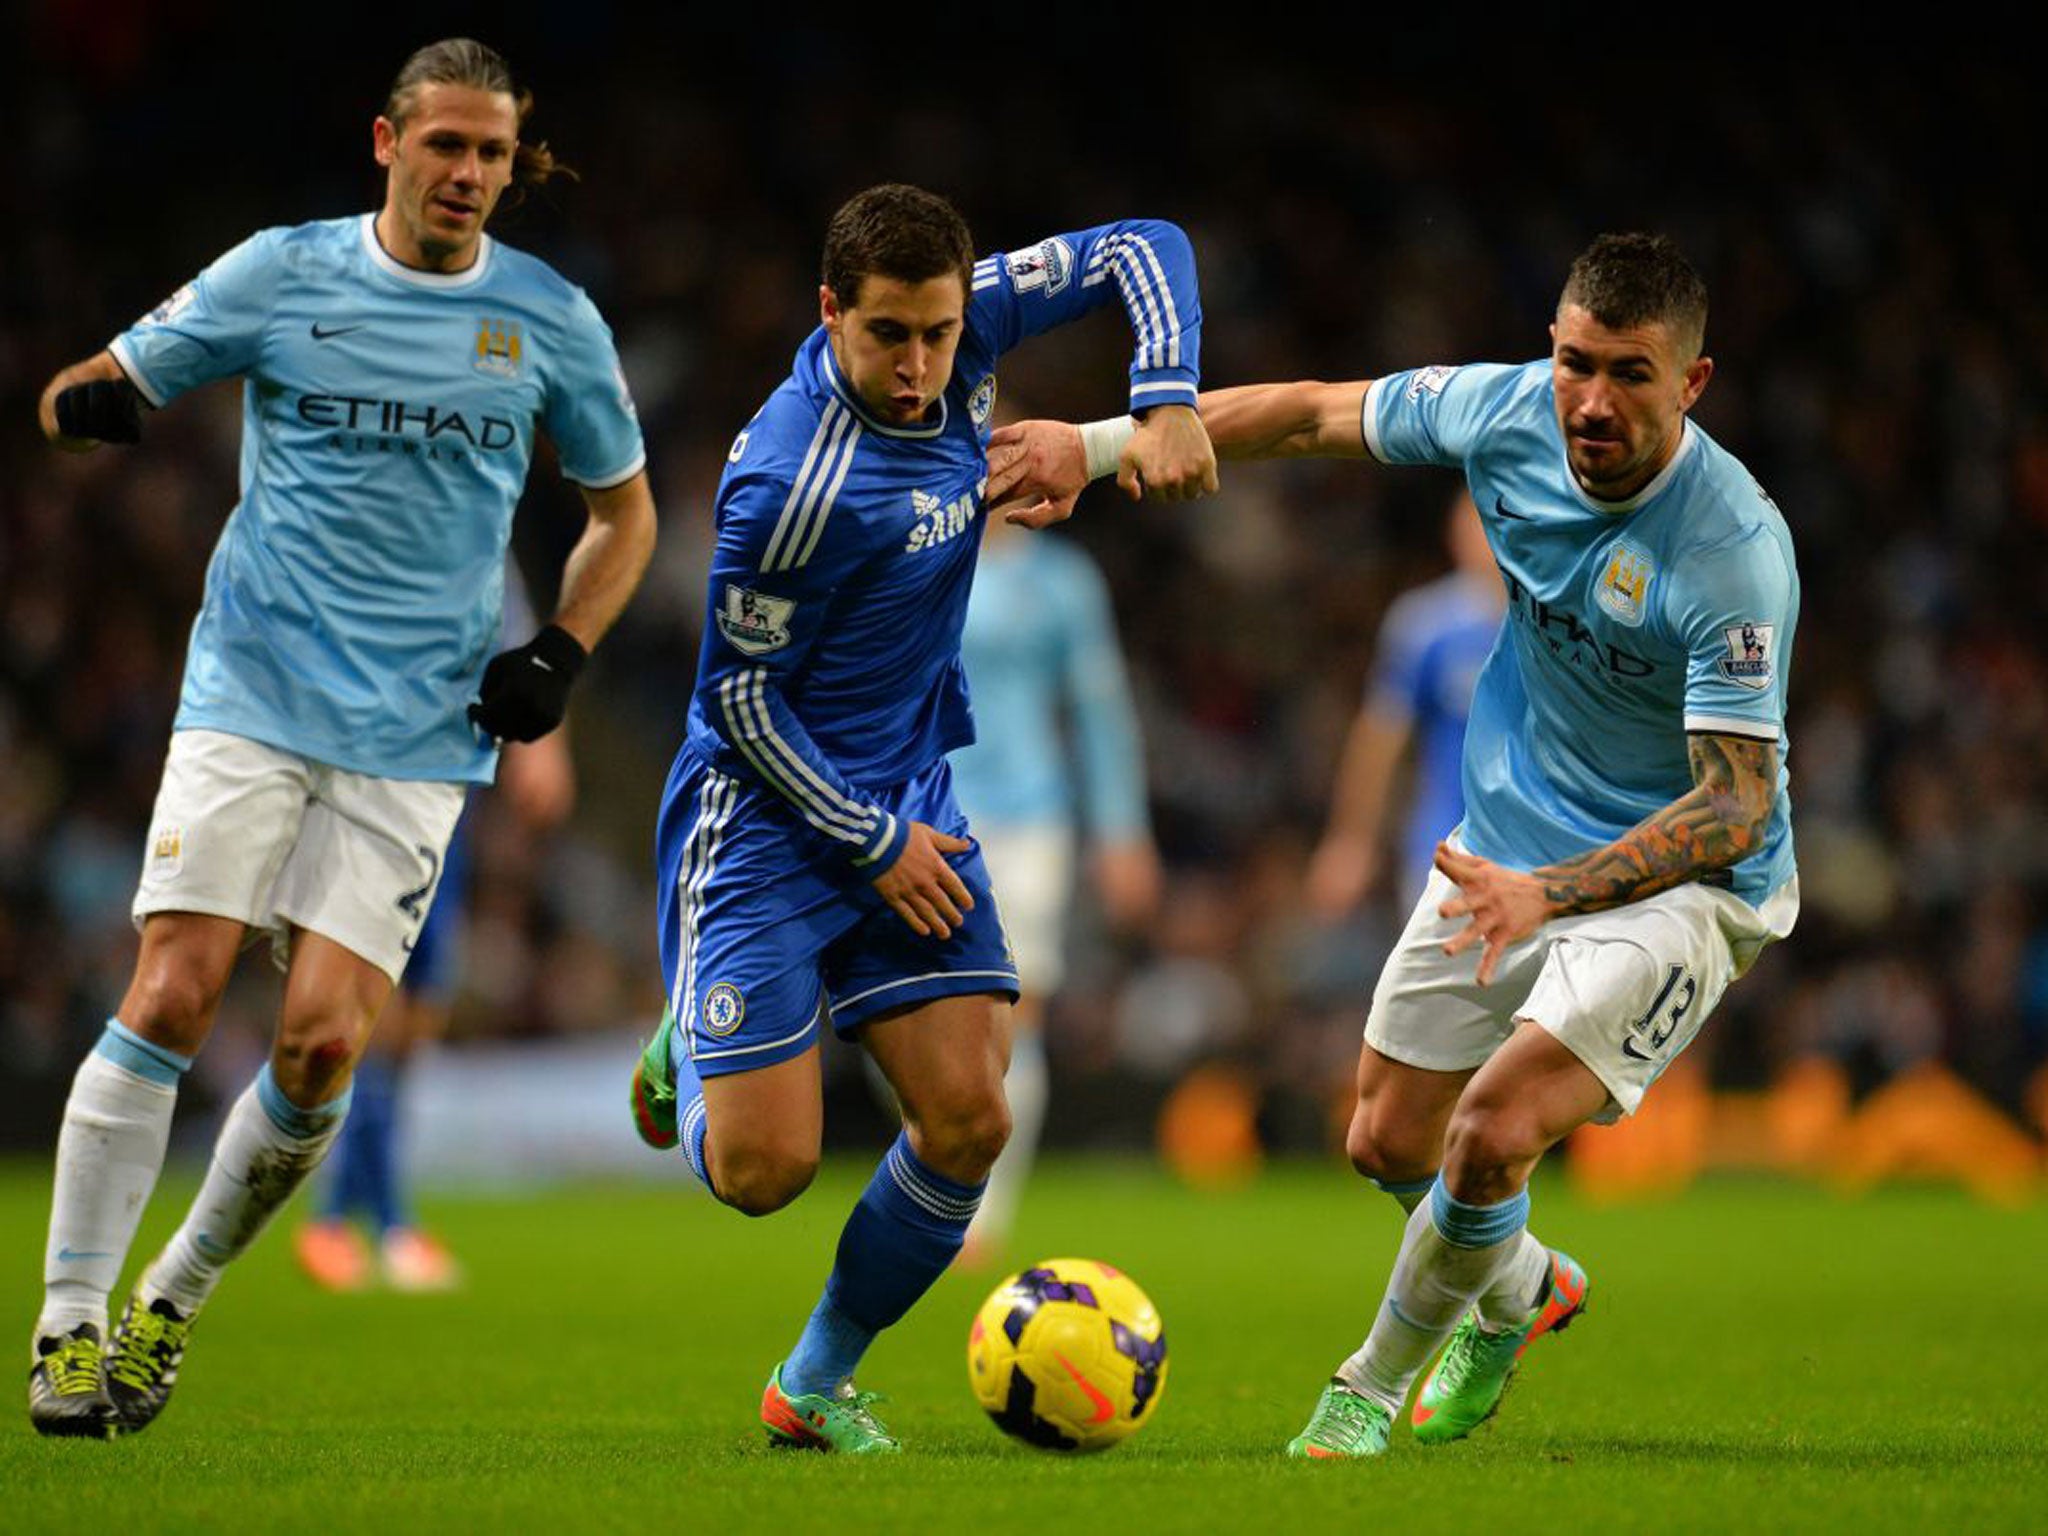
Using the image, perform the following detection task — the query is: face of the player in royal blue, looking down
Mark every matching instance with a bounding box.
[817,272,967,426]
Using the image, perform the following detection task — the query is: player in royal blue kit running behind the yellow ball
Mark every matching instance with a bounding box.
[633,184,1217,1454]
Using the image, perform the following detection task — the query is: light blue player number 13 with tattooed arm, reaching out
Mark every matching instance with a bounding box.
[989,236,1798,1458]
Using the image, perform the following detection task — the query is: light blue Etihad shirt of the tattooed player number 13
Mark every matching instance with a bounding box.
[1364,358,1798,903]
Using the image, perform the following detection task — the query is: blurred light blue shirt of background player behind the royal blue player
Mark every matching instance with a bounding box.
[952,532,1151,842]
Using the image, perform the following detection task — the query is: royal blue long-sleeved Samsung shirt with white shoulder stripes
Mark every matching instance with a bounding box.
[682,219,1202,868]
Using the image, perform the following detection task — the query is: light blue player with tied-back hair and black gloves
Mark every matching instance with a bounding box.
[29,39,655,1436]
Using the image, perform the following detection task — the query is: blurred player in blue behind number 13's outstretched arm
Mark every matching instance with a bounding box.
[1309,487,1507,920]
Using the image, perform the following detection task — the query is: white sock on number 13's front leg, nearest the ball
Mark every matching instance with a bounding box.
[1337,1182,1528,1413]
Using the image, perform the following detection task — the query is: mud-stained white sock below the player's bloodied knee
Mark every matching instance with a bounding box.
[137,1065,348,1317]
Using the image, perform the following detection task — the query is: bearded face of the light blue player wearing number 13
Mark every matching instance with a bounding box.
[1550,303,1714,502]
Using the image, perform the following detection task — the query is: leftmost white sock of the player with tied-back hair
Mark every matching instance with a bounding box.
[35,1020,193,1339]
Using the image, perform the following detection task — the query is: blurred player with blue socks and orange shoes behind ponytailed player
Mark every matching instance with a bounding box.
[293,561,575,1290]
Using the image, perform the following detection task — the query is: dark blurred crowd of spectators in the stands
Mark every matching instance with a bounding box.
[0,20,2048,1145]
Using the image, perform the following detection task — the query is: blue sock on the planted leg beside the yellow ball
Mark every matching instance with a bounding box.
[782,1133,985,1395]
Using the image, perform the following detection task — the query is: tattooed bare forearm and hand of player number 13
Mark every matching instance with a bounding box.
[1436,733,1778,987]
